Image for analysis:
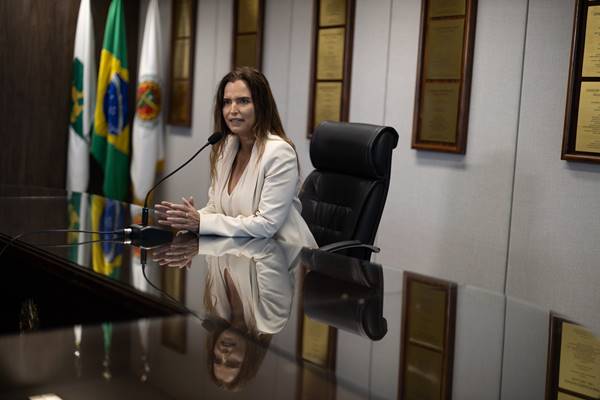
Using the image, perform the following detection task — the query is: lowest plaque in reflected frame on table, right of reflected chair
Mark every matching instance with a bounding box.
[402,344,443,400]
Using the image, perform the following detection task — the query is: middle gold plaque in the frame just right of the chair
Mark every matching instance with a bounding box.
[425,18,465,79]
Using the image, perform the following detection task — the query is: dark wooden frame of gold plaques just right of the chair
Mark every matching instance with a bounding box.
[412,0,477,154]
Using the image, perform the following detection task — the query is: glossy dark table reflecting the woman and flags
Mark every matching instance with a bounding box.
[0,187,597,400]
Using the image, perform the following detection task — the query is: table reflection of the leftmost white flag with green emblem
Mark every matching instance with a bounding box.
[67,192,90,267]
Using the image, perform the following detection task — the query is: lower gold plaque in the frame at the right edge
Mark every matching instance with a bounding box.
[575,82,600,153]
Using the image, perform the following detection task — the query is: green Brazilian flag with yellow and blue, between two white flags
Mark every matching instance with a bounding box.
[92,0,129,200]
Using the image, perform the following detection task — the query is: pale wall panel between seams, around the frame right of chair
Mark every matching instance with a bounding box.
[378,0,526,291]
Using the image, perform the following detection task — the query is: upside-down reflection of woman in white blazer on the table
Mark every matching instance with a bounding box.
[199,238,293,389]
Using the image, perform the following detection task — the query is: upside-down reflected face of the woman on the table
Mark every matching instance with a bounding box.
[213,329,246,383]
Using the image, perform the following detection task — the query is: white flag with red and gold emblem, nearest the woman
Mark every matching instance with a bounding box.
[131,0,164,204]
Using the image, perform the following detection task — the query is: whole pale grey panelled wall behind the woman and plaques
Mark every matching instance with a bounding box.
[146,0,600,324]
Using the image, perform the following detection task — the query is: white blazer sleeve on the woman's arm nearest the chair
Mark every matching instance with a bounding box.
[199,141,298,238]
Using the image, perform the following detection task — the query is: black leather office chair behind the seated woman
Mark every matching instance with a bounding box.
[300,121,398,260]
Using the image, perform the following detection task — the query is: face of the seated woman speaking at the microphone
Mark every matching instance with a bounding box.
[223,80,256,137]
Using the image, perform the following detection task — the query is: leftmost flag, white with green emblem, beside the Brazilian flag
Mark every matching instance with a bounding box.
[67,0,96,192]
